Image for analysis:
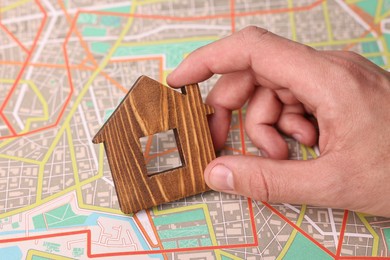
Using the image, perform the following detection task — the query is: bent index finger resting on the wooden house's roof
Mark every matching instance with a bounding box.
[167,26,329,105]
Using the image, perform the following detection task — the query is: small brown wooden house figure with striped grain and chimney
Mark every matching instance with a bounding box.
[93,76,215,214]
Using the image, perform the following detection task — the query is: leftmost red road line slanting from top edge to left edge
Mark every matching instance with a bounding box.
[0,0,47,136]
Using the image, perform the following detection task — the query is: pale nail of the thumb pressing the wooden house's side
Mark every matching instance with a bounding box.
[209,164,234,190]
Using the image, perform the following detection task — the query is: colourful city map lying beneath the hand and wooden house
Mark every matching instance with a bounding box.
[0,0,390,260]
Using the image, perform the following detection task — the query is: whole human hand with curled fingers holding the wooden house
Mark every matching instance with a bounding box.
[167,27,390,217]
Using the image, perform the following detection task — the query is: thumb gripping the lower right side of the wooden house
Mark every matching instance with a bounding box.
[205,156,337,206]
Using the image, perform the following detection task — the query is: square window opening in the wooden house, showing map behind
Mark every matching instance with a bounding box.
[140,129,185,177]
